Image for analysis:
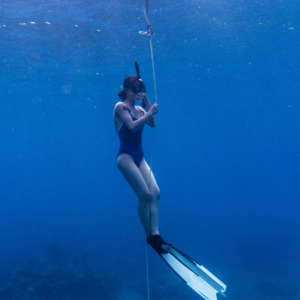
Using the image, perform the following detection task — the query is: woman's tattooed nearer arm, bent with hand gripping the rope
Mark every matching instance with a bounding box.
[116,103,158,132]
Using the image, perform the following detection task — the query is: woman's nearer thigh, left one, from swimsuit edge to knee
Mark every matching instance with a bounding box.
[117,155,149,199]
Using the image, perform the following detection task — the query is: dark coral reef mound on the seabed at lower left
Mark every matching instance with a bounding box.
[0,245,117,300]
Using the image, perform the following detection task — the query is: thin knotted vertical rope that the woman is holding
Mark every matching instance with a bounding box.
[139,0,157,300]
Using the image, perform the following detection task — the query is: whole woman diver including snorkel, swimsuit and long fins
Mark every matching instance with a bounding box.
[114,63,226,300]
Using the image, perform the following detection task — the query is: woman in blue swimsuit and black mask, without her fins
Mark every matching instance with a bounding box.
[114,74,160,237]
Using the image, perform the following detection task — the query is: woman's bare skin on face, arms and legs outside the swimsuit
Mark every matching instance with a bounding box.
[114,88,160,236]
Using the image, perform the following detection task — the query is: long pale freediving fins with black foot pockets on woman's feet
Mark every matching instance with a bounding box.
[147,235,226,300]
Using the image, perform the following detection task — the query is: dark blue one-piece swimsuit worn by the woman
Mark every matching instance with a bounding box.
[117,106,144,167]
